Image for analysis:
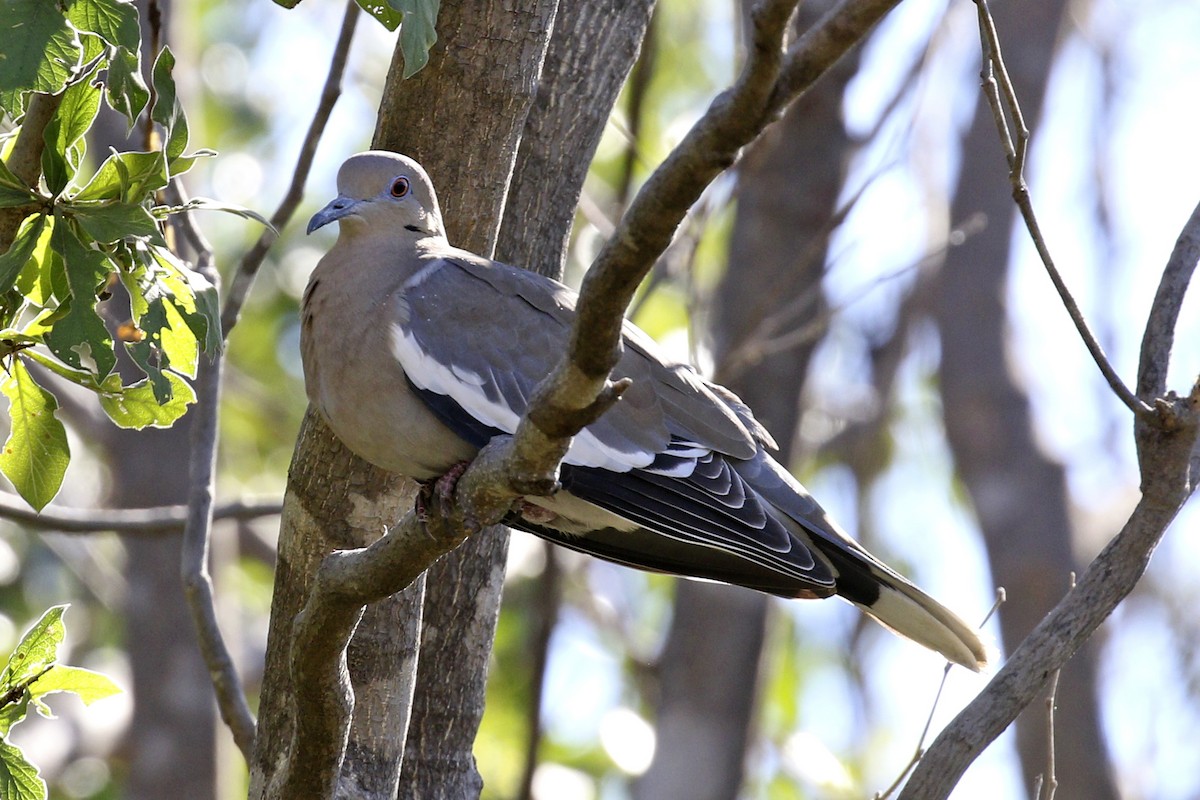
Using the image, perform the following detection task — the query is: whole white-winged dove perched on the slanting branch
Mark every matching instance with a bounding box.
[300,151,988,669]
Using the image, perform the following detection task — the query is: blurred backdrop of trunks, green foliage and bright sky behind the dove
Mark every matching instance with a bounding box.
[0,0,1200,800]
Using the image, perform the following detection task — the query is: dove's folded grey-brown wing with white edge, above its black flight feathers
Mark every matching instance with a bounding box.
[391,252,769,473]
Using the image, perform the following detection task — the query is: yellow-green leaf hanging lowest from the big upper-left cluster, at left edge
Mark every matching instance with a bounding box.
[0,357,71,510]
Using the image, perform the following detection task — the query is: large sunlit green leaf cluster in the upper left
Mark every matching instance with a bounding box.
[0,0,246,509]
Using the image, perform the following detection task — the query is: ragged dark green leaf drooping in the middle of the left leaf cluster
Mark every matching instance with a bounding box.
[46,215,116,379]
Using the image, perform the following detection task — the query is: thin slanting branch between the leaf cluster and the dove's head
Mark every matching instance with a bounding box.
[221,2,359,338]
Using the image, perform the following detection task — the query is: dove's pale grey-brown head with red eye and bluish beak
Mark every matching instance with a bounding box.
[308,150,445,239]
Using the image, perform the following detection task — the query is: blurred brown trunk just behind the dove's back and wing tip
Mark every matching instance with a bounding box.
[634,2,856,800]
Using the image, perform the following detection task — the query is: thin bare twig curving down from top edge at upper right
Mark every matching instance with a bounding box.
[976,0,1154,417]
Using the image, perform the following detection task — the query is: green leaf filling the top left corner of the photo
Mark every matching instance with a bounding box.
[0,0,83,119]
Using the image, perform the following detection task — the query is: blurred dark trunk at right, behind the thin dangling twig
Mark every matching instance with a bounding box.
[935,1,1116,800]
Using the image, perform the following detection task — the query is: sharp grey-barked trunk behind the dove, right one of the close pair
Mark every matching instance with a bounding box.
[380,0,652,799]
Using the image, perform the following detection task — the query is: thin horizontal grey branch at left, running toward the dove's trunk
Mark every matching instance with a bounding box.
[0,492,283,536]
